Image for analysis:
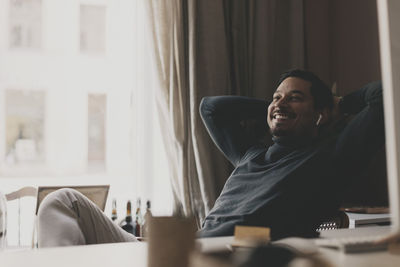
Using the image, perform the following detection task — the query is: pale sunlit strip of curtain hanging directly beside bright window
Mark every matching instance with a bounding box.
[146,0,196,218]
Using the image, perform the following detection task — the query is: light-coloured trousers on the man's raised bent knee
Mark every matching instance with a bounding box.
[38,188,137,247]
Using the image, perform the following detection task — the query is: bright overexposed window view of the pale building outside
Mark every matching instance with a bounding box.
[0,0,172,245]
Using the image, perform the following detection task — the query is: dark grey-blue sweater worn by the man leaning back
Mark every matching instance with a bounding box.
[198,82,384,239]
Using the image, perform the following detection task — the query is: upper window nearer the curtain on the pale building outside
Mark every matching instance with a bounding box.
[80,5,106,53]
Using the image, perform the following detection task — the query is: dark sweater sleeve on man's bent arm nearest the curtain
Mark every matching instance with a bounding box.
[200,96,268,166]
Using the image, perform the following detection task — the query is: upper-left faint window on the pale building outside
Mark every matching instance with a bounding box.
[9,0,42,49]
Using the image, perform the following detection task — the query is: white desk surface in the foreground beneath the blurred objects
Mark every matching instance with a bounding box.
[0,228,400,267]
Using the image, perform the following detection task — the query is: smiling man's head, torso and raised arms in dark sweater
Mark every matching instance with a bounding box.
[199,70,384,239]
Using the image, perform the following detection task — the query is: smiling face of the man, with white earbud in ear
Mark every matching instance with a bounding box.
[267,77,320,137]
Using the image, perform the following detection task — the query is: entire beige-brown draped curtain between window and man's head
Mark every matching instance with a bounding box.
[145,0,306,227]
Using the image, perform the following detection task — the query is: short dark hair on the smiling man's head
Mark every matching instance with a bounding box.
[278,69,333,109]
